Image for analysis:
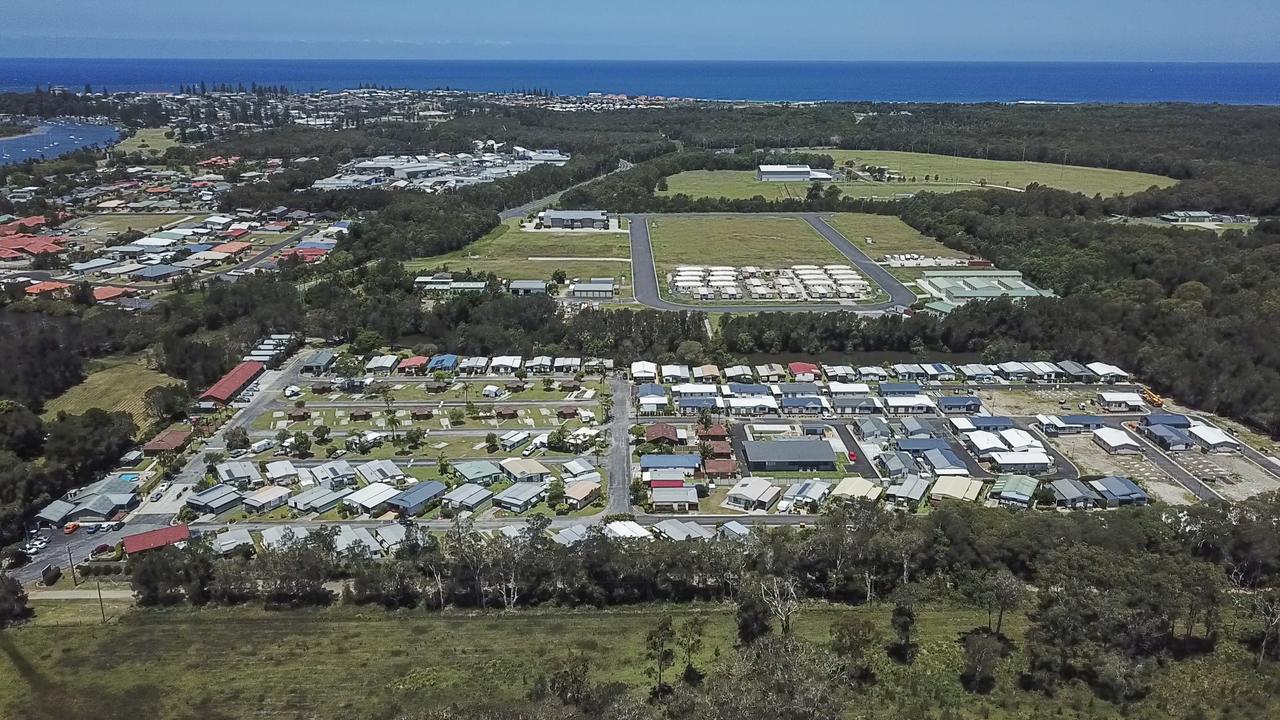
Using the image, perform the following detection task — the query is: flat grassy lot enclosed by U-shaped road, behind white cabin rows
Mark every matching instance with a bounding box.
[649,215,849,271]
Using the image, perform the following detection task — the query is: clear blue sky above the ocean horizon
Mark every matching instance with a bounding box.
[0,0,1280,61]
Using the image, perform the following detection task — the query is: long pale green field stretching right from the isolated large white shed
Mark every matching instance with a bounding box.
[819,150,1175,195]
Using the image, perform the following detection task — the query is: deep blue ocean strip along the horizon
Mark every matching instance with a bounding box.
[0,59,1280,105]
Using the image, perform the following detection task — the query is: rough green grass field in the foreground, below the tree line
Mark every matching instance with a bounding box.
[0,602,1280,720]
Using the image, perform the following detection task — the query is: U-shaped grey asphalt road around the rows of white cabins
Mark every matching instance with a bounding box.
[627,213,916,314]
